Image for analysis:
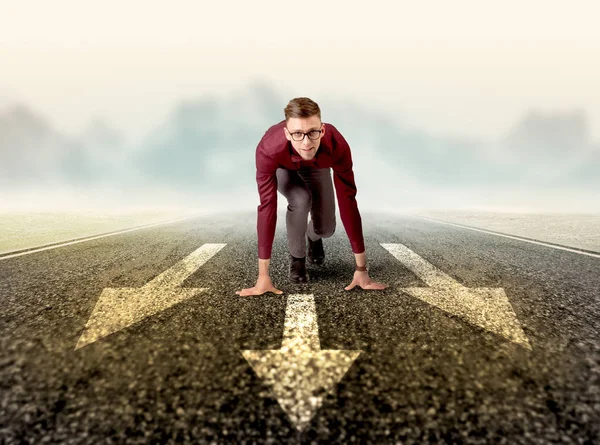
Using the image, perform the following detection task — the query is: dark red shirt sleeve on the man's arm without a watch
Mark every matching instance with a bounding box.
[256,144,277,259]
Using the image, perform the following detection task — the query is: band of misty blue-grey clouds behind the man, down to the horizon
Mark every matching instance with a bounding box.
[0,82,600,213]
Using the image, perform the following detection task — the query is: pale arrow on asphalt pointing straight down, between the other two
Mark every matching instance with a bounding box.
[242,294,362,431]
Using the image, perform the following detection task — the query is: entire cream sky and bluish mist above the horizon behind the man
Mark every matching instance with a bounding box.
[0,0,600,213]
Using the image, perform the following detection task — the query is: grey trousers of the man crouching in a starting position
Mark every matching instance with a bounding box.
[277,167,335,258]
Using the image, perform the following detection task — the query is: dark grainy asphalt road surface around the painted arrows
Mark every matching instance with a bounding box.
[0,212,600,444]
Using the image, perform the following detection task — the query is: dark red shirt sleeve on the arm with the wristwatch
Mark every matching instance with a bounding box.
[329,125,365,253]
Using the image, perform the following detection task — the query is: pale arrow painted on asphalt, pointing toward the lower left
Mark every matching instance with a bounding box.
[75,244,226,349]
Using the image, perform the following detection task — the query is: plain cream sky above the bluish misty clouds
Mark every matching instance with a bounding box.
[0,0,600,141]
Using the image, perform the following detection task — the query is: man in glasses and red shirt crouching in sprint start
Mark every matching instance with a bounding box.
[236,97,387,296]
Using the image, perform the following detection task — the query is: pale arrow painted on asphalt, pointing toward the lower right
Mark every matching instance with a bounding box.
[380,243,531,350]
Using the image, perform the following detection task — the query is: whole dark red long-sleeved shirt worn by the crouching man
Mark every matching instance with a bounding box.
[256,120,365,259]
